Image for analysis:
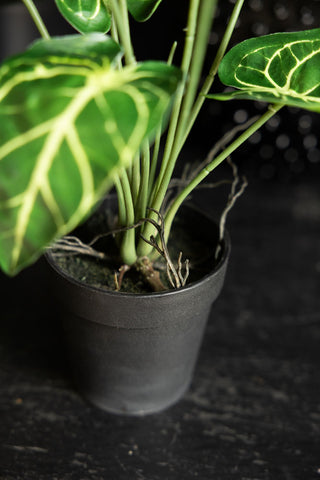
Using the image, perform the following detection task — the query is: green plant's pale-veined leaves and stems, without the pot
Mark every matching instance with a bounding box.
[0,0,320,286]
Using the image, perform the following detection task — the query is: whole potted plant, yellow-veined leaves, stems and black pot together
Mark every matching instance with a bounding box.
[0,0,320,414]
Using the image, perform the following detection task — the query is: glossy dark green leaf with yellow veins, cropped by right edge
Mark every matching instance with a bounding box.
[210,28,320,112]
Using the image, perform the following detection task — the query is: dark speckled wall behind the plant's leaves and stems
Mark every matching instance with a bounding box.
[0,0,320,183]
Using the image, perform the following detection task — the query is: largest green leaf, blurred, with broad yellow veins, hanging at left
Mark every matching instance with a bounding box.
[0,34,180,274]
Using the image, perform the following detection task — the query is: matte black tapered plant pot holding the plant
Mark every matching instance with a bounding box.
[48,204,230,415]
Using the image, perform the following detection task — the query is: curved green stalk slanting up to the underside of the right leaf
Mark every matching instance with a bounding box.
[165,104,283,240]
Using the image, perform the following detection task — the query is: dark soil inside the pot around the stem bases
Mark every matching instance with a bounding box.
[55,202,222,293]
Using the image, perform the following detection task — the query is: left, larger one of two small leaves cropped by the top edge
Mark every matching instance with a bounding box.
[55,0,111,33]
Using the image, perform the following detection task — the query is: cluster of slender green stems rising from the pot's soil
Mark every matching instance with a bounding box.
[23,0,281,265]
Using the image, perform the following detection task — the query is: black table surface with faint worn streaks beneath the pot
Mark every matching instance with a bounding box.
[0,171,320,480]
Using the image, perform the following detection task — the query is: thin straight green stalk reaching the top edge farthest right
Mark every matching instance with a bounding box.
[180,0,245,146]
